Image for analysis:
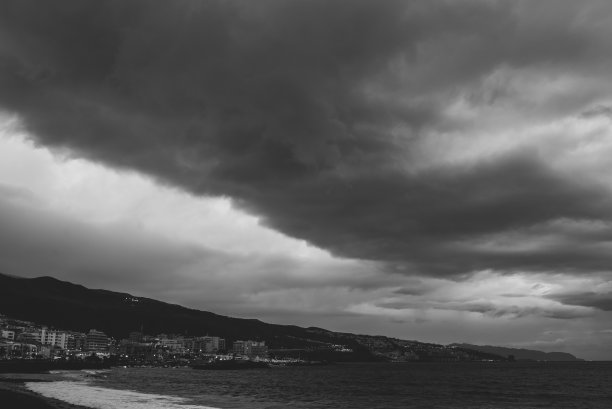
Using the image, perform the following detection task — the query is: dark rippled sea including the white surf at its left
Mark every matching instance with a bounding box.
[28,362,612,409]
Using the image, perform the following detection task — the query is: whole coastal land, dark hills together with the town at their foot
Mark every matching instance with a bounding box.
[0,274,578,367]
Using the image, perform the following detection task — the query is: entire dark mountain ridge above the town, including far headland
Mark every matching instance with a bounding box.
[0,274,577,362]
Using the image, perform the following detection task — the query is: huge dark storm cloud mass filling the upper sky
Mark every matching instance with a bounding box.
[0,0,612,275]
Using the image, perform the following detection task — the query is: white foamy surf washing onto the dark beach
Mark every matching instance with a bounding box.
[26,381,215,409]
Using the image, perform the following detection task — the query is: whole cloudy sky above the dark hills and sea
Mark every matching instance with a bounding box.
[0,0,612,359]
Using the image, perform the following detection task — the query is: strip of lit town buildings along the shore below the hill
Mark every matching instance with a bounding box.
[0,315,524,367]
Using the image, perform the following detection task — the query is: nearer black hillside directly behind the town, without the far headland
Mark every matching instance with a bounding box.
[0,274,378,360]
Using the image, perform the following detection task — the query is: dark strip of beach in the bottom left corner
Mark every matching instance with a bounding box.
[0,374,91,409]
